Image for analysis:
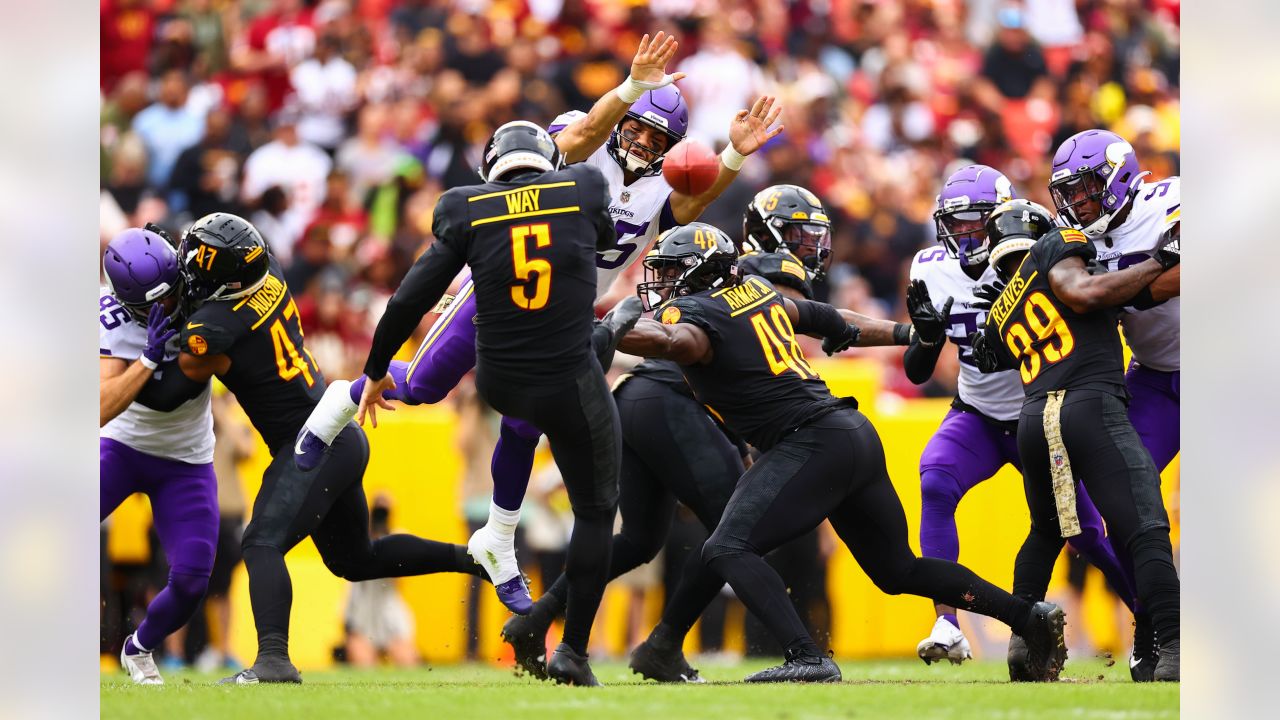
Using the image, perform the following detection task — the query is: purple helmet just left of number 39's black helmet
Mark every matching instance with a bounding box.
[933,165,1015,268]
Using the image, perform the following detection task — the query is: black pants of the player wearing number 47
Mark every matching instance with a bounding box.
[241,423,484,659]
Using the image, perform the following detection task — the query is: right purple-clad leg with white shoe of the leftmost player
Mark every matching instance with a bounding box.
[122,454,218,682]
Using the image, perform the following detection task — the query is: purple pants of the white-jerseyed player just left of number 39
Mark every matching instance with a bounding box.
[920,407,1134,607]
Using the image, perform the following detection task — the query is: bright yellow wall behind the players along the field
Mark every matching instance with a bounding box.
[104,361,1178,670]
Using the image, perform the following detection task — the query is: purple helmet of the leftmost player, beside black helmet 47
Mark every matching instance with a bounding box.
[102,228,182,322]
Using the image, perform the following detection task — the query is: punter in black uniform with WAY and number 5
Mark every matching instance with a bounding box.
[357,122,627,685]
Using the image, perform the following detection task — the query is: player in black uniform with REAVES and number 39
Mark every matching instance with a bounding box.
[972,200,1180,680]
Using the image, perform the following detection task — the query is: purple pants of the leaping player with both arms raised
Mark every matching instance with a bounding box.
[351,269,543,510]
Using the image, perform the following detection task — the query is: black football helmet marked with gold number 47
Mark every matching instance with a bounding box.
[178,213,270,309]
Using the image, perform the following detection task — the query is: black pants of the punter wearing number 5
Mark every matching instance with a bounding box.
[476,355,622,655]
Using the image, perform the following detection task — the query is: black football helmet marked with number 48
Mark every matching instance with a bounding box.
[636,223,737,311]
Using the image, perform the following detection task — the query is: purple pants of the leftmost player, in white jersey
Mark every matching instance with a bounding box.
[99,438,218,650]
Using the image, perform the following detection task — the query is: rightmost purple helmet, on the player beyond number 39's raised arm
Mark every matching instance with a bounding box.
[1048,129,1149,237]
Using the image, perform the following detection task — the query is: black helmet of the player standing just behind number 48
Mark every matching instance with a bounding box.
[742,184,831,281]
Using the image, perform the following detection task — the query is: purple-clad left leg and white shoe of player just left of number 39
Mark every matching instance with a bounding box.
[916,409,1009,665]
